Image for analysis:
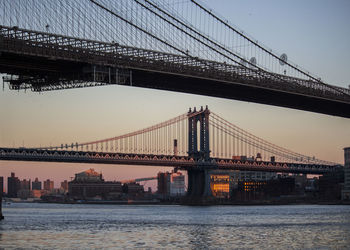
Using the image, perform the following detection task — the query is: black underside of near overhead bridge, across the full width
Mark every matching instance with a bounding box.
[0,52,350,118]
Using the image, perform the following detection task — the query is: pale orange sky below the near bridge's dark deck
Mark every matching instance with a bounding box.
[0,86,350,191]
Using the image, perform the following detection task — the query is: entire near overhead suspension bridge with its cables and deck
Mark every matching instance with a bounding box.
[0,0,350,118]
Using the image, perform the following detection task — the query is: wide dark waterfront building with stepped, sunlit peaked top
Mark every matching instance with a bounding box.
[68,168,122,199]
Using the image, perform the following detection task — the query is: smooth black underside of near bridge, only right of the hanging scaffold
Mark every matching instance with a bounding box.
[133,70,350,118]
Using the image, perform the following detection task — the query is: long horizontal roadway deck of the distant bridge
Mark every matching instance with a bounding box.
[0,148,341,174]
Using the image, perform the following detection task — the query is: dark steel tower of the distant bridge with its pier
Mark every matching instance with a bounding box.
[187,106,215,201]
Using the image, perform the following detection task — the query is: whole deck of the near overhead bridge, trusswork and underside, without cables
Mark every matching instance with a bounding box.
[0,26,350,118]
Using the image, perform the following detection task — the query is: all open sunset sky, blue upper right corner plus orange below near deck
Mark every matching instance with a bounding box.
[0,0,350,188]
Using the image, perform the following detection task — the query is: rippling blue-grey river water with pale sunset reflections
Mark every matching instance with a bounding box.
[0,203,350,249]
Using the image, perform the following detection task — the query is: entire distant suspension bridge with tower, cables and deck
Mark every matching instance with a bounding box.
[0,107,342,196]
